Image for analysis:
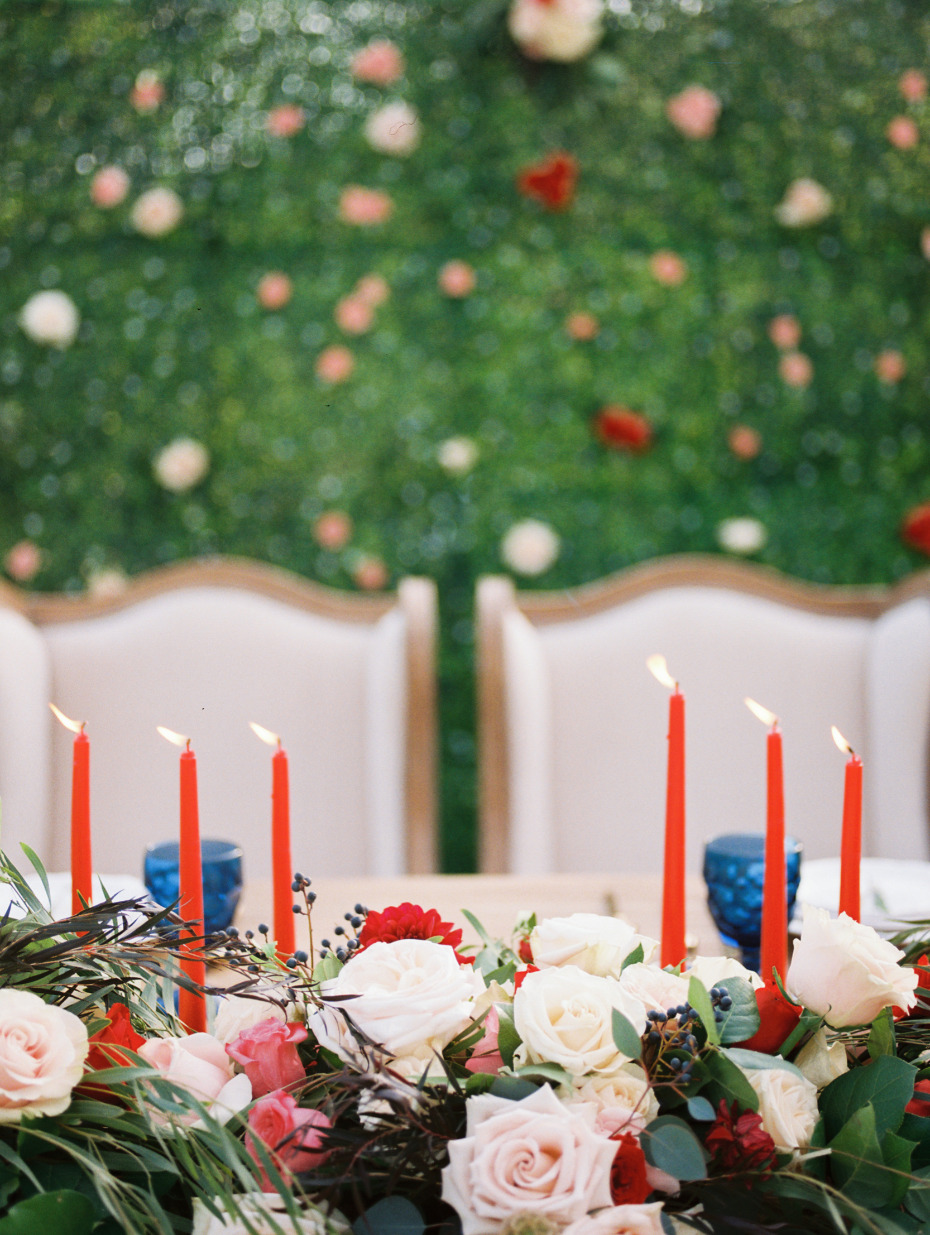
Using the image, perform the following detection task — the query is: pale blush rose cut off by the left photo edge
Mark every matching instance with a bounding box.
[0,990,88,1124]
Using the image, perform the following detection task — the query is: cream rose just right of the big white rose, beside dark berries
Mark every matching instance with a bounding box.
[514,965,646,1076]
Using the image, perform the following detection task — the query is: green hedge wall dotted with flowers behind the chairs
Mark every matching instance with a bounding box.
[0,0,930,869]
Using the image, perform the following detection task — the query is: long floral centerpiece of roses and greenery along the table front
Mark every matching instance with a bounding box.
[0,862,930,1235]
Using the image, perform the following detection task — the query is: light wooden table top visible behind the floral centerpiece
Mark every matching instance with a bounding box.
[236,874,721,953]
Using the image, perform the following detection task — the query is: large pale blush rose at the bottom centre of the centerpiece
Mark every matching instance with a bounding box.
[442,1081,616,1235]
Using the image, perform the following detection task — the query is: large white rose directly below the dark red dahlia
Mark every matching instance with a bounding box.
[308,939,484,1077]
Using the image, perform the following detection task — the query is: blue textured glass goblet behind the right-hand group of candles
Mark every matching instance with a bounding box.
[704,832,802,973]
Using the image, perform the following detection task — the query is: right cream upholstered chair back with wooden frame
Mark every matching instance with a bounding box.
[478,557,930,873]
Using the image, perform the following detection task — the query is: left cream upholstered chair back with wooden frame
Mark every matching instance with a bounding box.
[0,559,436,878]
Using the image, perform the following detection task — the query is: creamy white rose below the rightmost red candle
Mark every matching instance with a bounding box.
[784,905,918,1029]
